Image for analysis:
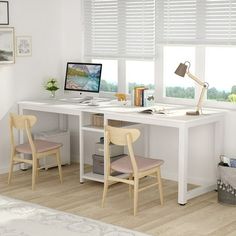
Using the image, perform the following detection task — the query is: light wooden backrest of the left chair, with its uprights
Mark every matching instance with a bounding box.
[9,113,37,153]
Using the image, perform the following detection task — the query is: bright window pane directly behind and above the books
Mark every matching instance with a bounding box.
[126,61,155,93]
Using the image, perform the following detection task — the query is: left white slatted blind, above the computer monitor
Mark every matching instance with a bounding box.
[84,0,156,59]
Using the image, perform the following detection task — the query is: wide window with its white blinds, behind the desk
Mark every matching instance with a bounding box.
[84,0,236,107]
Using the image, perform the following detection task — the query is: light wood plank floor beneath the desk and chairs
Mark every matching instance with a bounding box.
[0,165,236,236]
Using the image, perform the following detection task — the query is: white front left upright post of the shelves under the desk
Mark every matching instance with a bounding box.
[79,112,84,184]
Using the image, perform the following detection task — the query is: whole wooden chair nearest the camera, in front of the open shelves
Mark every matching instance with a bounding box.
[102,126,164,216]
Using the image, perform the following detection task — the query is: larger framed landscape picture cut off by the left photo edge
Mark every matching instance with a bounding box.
[0,27,15,64]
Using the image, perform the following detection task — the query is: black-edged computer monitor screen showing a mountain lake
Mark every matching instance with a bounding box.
[64,62,102,93]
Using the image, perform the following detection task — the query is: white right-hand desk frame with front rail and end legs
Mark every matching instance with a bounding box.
[105,111,224,205]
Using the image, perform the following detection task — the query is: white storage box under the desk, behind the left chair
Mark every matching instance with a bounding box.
[34,130,70,169]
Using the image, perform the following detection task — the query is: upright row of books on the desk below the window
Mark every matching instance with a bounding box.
[133,86,154,107]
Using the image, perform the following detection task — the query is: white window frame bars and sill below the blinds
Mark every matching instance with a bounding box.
[88,45,236,110]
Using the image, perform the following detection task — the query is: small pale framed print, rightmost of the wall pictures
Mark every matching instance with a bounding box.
[16,36,32,57]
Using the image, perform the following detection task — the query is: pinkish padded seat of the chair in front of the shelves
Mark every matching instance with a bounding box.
[111,156,164,173]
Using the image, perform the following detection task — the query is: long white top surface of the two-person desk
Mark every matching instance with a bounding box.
[18,99,225,126]
